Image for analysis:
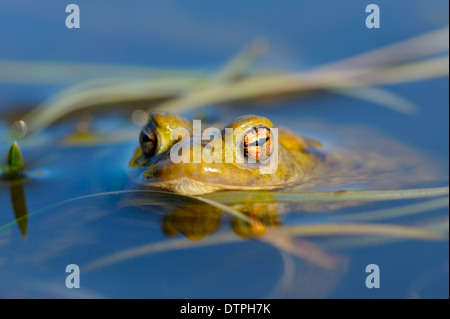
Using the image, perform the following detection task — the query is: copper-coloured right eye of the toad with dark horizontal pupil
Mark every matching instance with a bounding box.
[243,126,273,162]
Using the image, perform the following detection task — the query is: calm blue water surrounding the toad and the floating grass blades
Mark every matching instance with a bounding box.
[0,0,449,298]
